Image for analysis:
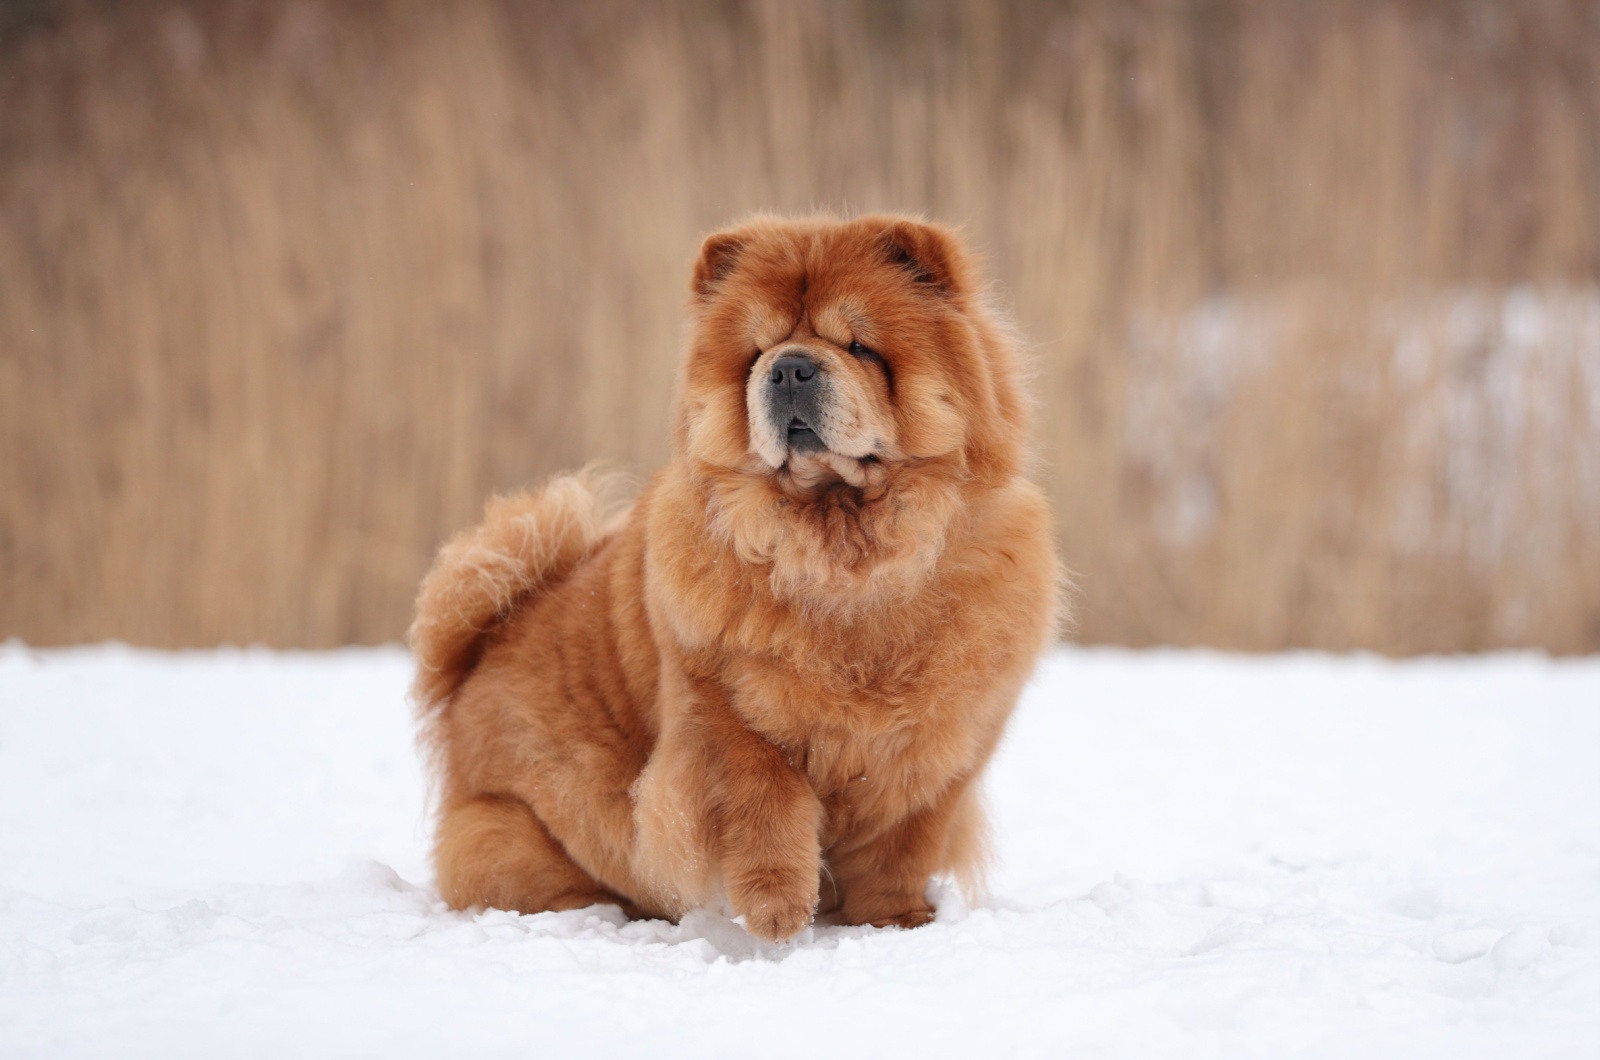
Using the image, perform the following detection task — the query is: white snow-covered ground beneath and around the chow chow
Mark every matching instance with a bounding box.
[0,645,1600,1058]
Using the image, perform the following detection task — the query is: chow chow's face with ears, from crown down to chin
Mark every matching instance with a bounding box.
[678,218,1019,496]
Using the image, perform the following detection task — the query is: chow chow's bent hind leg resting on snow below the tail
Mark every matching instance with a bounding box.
[434,796,634,914]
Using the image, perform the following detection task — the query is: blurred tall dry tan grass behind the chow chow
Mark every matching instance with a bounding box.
[0,0,1600,653]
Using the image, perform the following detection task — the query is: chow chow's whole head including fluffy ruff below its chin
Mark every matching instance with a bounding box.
[677,216,1024,607]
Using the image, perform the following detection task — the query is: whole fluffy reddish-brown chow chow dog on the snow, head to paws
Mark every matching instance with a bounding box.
[411,216,1059,940]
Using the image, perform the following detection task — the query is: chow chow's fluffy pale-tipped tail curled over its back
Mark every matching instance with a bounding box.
[410,469,618,714]
